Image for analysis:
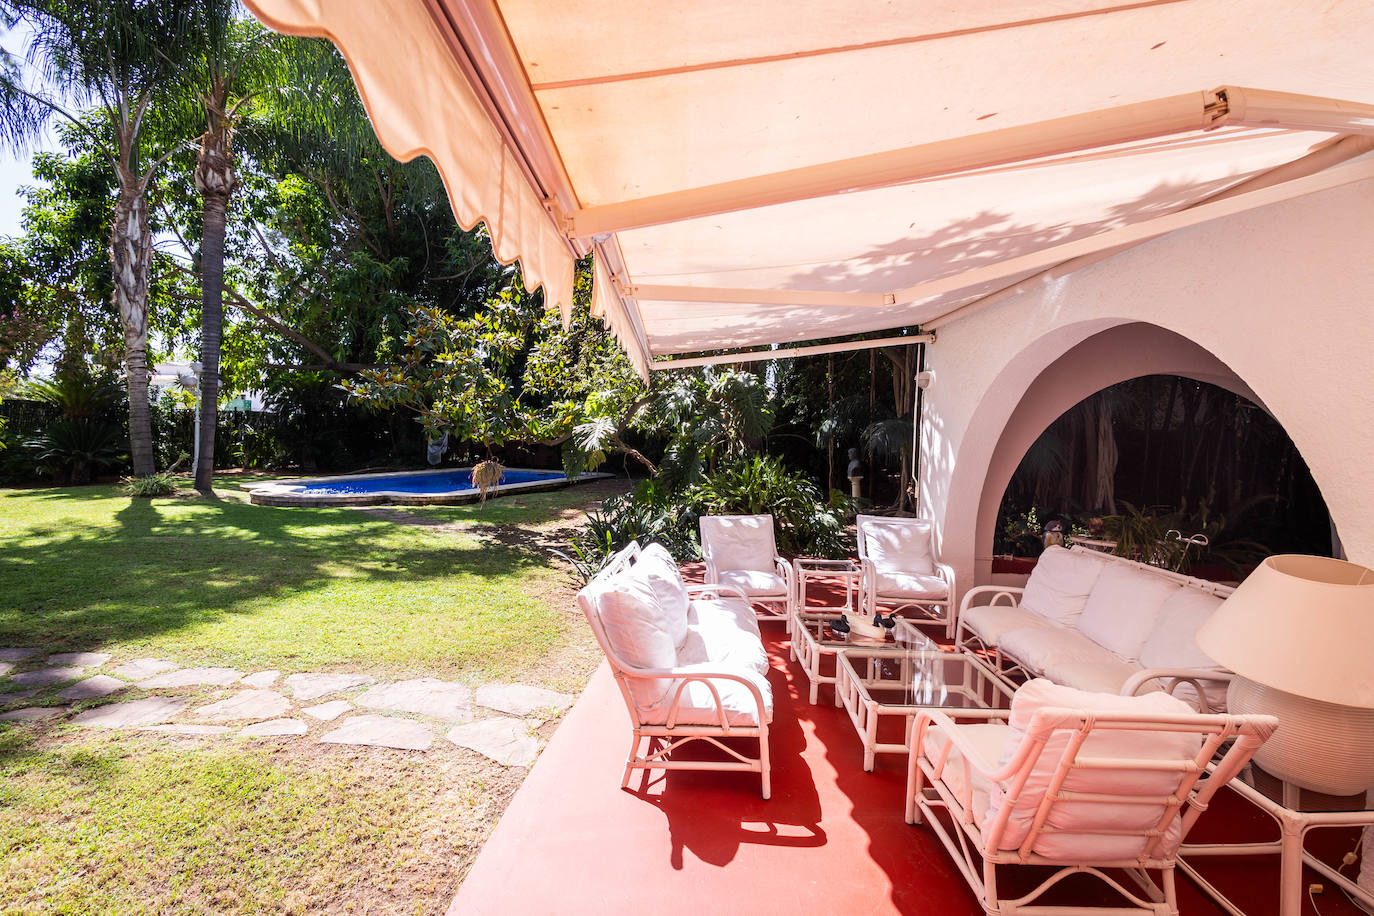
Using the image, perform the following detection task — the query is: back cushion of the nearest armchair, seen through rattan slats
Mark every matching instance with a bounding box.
[982,678,1202,862]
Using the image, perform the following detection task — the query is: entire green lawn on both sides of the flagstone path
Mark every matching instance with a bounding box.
[0,478,620,913]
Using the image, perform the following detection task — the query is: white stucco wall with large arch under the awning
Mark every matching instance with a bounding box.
[922,175,1374,591]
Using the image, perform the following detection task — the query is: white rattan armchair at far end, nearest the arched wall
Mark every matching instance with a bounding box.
[855,515,955,639]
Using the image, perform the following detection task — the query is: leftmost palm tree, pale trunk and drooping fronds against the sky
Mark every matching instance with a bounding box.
[0,0,194,477]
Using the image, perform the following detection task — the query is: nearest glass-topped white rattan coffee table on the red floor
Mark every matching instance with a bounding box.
[835,619,1011,772]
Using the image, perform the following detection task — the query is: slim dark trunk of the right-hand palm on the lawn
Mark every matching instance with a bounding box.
[195,87,238,494]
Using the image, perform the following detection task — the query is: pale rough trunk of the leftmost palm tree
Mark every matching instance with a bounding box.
[110,163,157,477]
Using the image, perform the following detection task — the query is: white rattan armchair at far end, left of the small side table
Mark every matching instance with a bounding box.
[701,515,796,619]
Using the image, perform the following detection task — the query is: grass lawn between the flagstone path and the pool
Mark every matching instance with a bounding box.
[0,486,618,677]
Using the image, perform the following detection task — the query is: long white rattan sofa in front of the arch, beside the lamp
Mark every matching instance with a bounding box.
[956,547,1234,713]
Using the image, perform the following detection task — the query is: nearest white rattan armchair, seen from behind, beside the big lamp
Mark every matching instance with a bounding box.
[907,678,1278,916]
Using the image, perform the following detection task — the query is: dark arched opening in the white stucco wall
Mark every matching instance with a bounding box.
[992,375,1333,580]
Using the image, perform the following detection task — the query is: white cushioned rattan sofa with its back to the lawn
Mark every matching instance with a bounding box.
[577,542,774,798]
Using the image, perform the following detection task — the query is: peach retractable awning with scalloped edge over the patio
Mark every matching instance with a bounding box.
[241,0,1374,372]
